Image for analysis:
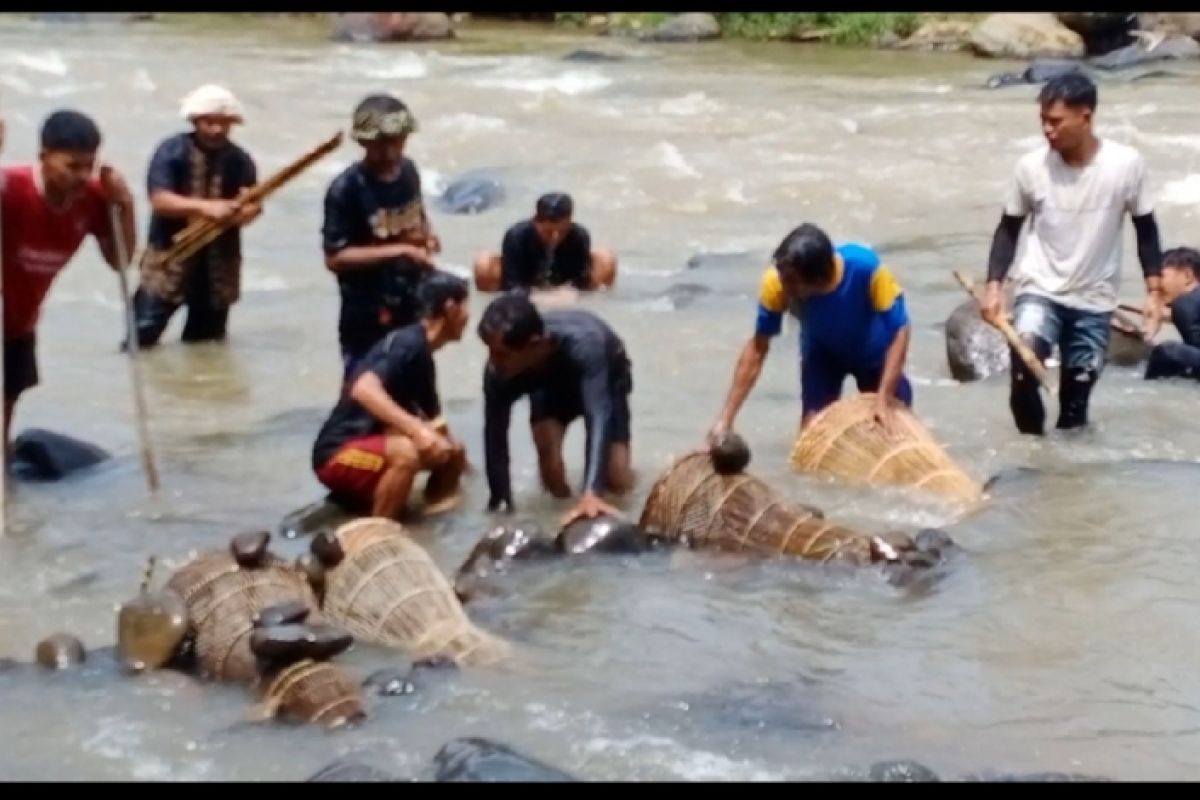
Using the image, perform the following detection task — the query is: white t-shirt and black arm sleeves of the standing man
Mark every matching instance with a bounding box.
[992,139,1159,312]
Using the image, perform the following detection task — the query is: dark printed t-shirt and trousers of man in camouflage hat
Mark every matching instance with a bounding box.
[322,158,428,362]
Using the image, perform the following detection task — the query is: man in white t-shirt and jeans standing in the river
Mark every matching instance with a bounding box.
[983,73,1163,434]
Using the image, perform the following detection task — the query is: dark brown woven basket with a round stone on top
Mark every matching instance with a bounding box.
[640,451,876,565]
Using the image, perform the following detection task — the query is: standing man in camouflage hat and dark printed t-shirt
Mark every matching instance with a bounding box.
[322,95,442,379]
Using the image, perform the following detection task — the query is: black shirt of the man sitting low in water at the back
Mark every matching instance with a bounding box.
[500,219,592,291]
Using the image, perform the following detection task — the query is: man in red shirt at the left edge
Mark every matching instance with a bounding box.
[0,110,137,447]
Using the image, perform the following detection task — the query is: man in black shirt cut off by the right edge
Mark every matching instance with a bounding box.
[1146,247,1200,380]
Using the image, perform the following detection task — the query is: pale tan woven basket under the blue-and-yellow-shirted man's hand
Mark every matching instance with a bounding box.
[791,393,983,503]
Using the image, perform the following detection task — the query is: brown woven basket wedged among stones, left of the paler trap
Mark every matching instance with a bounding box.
[167,553,319,684]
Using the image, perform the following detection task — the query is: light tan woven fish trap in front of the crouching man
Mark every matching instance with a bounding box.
[324,517,509,666]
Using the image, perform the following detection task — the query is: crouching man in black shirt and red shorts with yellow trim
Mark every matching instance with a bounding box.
[312,272,470,519]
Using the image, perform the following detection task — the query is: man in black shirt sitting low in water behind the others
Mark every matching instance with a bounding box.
[475,192,617,297]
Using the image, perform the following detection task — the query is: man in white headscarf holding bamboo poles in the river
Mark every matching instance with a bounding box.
[133,84,262,347]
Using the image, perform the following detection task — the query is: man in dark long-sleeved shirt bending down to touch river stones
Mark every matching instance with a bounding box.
[479,293,634,524]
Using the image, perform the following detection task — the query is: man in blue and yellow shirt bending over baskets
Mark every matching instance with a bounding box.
[709,223,912,440]
